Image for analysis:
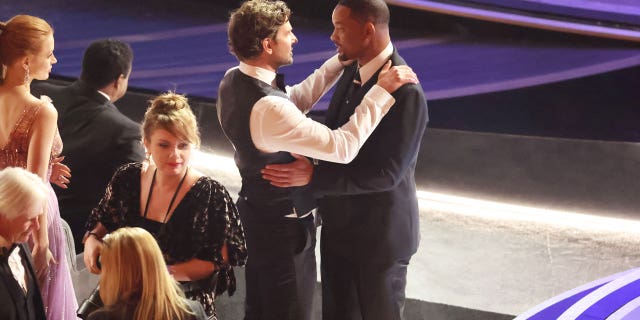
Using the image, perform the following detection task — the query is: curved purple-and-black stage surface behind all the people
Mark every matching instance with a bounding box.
[8,0,640,141]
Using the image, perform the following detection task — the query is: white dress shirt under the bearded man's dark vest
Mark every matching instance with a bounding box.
[234,55,395,163]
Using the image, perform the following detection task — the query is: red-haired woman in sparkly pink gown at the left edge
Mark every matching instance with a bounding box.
[0,15,78,319]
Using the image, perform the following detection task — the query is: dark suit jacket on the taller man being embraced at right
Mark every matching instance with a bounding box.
[311,50,428,261]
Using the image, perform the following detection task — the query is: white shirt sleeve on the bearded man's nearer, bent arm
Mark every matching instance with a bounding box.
[249,85,395,163]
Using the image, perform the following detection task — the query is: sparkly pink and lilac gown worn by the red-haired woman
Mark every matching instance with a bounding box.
[0,97,78,320]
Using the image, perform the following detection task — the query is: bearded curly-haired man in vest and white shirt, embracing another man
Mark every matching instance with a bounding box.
[217,0,417,320]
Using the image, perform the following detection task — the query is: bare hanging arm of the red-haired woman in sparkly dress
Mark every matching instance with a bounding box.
[27,104,58,281]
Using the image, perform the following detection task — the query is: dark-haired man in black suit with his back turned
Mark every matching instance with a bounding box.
[45,39,144,252]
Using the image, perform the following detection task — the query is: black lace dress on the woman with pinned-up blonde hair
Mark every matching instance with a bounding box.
[86,163,247,319]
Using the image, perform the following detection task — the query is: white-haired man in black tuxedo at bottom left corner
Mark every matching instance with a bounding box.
[0,167,49,320]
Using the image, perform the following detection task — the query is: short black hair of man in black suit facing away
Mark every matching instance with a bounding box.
[80,39,133,89]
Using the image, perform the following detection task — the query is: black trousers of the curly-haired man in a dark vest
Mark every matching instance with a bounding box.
[238,201,316,320]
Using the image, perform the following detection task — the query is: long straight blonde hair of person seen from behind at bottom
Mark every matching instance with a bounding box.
[100,227,193,320]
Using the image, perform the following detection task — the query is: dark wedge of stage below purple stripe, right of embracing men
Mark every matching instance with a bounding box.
[429,66,640,142]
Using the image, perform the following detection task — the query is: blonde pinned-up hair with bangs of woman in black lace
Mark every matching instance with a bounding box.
[142,92,200,148]
